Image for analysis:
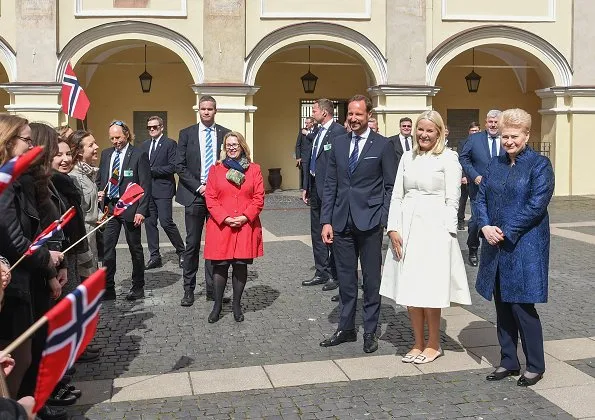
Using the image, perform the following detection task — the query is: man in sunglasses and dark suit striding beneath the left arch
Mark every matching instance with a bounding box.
[140,116,184,270]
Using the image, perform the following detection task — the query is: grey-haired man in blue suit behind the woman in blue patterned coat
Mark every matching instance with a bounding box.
[459,109,504,267]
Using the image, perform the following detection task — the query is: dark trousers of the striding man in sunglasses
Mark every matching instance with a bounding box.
[145,197,185,258]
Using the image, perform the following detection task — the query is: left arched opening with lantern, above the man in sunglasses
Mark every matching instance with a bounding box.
[73,39,196,148]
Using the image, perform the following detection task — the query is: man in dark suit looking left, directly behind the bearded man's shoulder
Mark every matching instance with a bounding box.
[302,98,346,291]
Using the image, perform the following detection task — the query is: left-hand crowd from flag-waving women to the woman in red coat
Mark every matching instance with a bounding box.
[0,96,264,419]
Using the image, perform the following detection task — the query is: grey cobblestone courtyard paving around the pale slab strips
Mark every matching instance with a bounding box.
[67,194,595,419]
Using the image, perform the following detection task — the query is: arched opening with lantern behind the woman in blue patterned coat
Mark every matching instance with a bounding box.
[432,44,555,158]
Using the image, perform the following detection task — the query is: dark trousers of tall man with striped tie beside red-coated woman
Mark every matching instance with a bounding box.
[183,202,213,294]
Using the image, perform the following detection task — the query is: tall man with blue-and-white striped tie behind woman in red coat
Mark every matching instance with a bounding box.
[176,96,230,306]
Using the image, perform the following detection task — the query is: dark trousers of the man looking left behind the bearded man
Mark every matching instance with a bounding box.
[309,176,337,279]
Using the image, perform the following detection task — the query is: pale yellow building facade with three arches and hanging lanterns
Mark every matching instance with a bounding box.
[0,0,595,195]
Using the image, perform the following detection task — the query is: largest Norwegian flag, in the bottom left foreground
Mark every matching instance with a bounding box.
[33,268,105,413]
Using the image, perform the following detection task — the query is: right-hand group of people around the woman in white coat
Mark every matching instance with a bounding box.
[296,95,554,386]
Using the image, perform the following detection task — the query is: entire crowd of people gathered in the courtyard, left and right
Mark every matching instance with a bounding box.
[0,95,554,419]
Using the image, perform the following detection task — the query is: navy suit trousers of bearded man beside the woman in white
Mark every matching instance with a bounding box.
[333,217,383,333]
